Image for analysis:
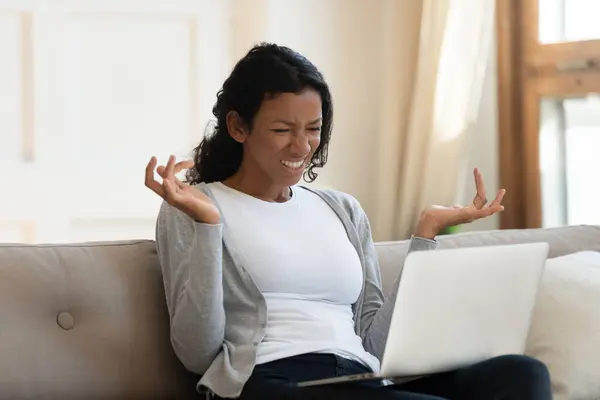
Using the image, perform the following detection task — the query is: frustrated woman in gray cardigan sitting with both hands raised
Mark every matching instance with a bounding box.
[146,44,550,400]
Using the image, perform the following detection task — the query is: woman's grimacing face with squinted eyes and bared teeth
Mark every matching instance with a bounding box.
[236,89,322,186]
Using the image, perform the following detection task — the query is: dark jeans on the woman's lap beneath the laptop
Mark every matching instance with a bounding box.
[218,354,552,400]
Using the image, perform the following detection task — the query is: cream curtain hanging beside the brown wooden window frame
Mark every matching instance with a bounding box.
[374,0,494,240]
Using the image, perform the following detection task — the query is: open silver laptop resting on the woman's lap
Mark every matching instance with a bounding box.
[298,243,548,387]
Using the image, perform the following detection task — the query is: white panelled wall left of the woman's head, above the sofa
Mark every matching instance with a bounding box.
[0,0,229,243]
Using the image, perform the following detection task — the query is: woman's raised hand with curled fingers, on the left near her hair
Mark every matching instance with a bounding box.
[145,156,221,224]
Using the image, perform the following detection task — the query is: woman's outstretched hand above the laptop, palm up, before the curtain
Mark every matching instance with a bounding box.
[415,168,506,239]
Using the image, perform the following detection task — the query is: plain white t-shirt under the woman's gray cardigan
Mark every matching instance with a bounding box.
[209,182,379,371]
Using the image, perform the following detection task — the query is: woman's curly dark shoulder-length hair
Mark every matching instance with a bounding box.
[186,43,333,184]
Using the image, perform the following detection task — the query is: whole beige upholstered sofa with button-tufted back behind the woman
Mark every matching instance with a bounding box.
[0,226,600,400]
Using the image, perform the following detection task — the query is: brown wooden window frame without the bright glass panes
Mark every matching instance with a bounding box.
[496,0,600,229]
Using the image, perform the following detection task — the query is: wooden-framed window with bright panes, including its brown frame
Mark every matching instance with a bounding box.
[497,0,600,228]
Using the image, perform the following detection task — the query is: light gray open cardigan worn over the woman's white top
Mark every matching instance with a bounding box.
[156,183,437,398]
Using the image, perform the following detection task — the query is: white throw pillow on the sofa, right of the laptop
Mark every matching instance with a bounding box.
[526,251,600,400]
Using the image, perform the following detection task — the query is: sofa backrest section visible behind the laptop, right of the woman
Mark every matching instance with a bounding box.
[375,225,600,294]
